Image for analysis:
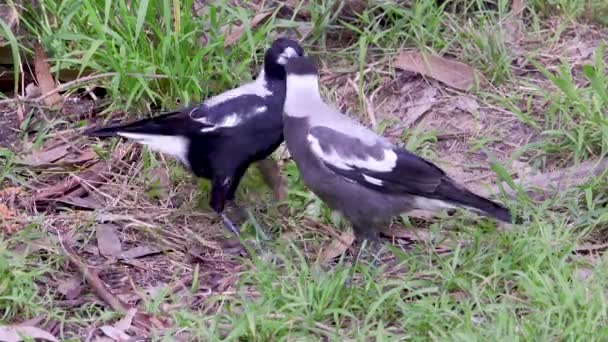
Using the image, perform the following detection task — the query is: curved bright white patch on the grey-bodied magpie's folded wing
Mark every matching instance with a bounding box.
[306,134,397,172]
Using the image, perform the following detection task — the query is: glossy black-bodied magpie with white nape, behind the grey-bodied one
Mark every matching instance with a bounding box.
[85,38,304,234]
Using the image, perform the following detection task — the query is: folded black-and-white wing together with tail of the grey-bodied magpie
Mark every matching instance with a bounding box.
[307,126,512,222]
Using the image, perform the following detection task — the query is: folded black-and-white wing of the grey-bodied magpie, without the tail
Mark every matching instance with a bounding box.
[307,126,447,197]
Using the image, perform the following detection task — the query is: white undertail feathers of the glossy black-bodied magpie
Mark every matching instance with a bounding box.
[118,132,190,167]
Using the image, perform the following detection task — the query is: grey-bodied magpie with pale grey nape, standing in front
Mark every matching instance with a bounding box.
[283,57,511,242]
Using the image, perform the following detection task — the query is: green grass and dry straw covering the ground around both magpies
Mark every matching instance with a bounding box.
[0,0,608,341]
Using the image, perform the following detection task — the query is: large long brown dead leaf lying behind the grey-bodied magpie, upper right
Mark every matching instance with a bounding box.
[394,51,486,90]
